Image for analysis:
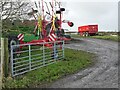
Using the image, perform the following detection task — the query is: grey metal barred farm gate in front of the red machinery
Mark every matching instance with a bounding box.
[11,41,64,77]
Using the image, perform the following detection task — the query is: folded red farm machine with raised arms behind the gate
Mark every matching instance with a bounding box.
[9,0,73,51]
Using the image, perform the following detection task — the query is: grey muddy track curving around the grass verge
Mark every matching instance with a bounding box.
[49,38,118,88]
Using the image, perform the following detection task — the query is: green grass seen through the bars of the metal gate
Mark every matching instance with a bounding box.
[14,45,53,74]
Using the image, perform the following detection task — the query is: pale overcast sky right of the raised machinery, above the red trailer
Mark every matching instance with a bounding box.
[60,0,118,31]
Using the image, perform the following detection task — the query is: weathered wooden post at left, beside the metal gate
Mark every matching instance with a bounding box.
[1,38,9,79]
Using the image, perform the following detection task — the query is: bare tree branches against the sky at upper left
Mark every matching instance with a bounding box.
[0,0,32,20]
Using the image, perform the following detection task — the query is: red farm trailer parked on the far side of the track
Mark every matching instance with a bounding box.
[78,25,98,36]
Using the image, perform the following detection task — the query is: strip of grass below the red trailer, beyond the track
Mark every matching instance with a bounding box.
[72,35,120,42]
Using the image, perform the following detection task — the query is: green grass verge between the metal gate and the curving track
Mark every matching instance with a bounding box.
[3,49,95,88]
